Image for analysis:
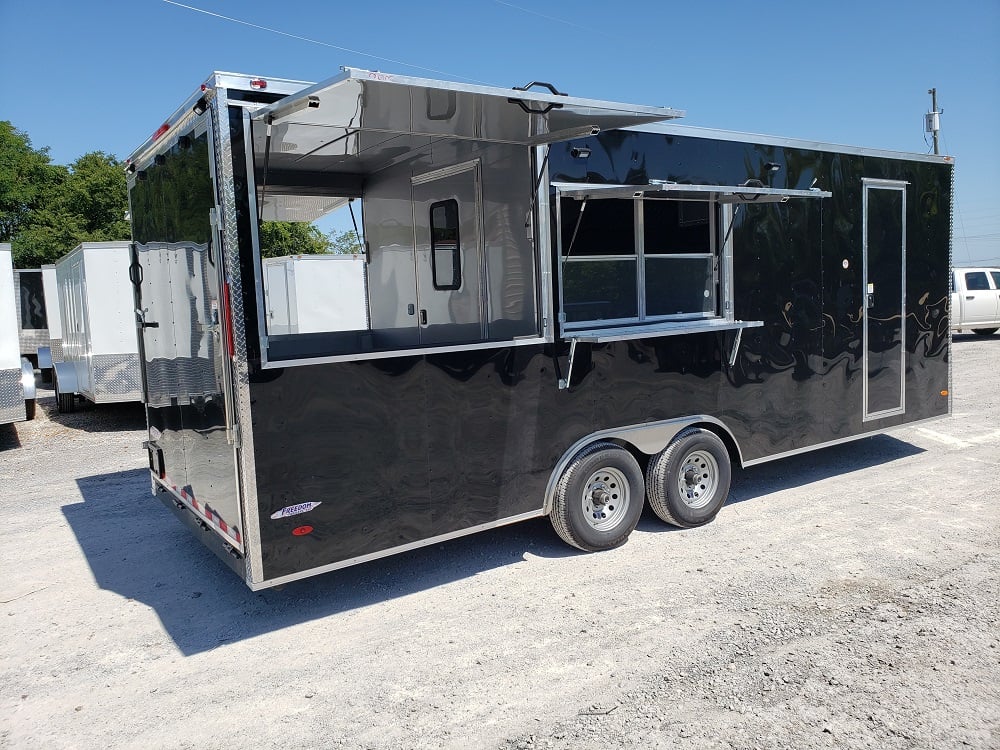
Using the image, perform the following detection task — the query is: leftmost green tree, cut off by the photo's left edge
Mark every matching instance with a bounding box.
[0,120,66,242]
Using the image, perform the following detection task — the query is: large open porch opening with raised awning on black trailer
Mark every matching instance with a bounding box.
[246,68,683,367]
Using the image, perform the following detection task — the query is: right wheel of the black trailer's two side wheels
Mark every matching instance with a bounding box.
[646,427,732,529]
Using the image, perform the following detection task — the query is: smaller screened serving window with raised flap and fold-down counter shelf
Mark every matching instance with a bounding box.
[553,182,831,342]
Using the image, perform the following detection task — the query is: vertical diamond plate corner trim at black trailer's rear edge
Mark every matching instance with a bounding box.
[212,91,264,584]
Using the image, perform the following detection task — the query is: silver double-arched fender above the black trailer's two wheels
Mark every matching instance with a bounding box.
[542,414,743,515]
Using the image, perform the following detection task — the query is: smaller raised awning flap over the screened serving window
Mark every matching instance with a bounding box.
[552,182,833,203]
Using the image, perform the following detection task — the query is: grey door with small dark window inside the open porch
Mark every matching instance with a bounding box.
[411,159,486,344]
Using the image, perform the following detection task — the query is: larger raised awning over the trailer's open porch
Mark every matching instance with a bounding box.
[253,68,684,179]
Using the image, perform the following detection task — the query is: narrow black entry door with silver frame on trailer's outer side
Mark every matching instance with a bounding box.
[862,180,906,420]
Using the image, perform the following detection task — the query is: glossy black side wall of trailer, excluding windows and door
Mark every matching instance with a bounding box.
[251,133,950,579]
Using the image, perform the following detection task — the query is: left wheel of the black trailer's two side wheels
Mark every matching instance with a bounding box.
[549,443,644,552]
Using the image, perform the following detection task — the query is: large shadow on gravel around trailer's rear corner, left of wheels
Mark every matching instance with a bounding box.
[62,469,575,655]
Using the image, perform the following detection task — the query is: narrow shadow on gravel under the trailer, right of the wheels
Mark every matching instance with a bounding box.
[727,435,924,505]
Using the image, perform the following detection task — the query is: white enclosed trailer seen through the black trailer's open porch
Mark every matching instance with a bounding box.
[263,254,369,335]
